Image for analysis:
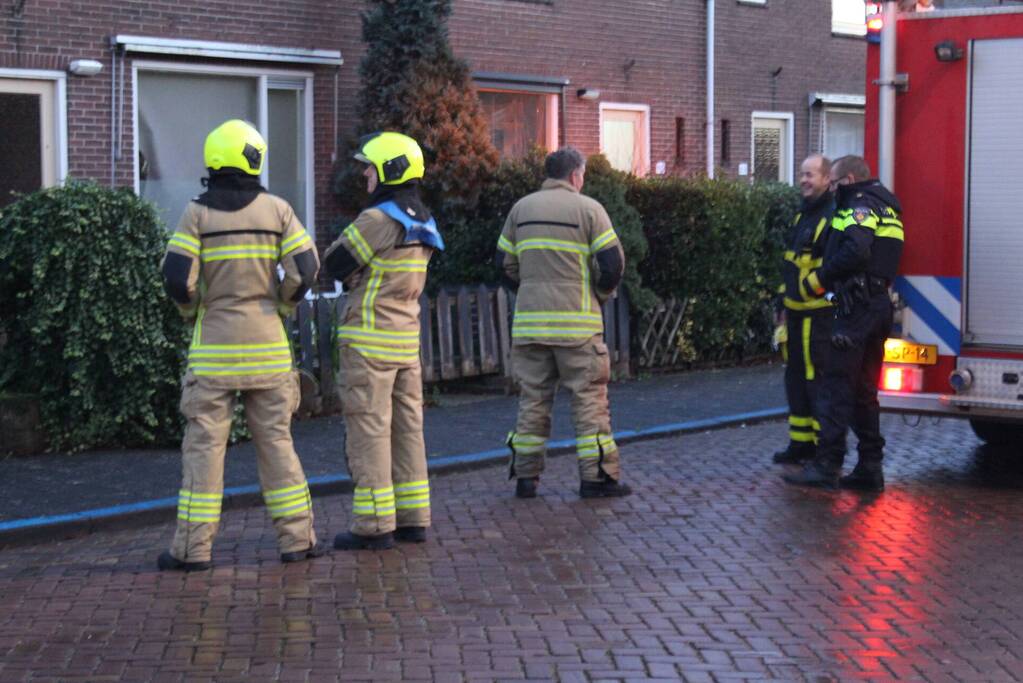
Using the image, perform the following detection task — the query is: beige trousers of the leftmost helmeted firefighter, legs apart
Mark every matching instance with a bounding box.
[171,372,316,562]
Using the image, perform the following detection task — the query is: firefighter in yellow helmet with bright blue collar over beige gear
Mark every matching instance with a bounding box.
[323,132,444,550]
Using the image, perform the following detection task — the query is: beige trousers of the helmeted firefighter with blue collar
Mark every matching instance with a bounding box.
[338,347,430,536]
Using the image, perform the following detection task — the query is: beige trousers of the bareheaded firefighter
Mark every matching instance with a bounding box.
[506,336,620,482]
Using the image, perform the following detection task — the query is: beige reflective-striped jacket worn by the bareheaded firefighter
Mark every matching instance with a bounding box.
[497,179,625,347]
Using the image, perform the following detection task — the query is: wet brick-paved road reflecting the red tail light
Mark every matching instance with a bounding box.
[0,417,1023,682]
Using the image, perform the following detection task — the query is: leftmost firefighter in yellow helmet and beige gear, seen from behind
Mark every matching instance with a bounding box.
[158,120,323,571]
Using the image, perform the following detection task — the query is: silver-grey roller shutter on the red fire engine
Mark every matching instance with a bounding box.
[961,39,1023,347]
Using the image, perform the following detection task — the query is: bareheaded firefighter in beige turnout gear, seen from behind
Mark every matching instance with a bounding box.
[497,147,630,498]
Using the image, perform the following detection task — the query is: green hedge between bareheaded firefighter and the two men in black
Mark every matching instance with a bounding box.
[628,178,798,360]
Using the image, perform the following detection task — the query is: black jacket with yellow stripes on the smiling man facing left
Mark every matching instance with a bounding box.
[782,192,835,313]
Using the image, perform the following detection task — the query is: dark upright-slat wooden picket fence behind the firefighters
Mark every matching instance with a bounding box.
[287,285,631,409]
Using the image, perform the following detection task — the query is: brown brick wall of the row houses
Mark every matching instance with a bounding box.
[0,0,865,241]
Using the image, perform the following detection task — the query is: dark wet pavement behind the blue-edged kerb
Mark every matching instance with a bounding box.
[0,364,785,522]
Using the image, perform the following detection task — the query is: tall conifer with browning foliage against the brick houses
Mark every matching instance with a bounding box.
[337,0,497,211]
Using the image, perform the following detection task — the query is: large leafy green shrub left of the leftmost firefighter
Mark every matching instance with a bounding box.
[0,182,187,450]
